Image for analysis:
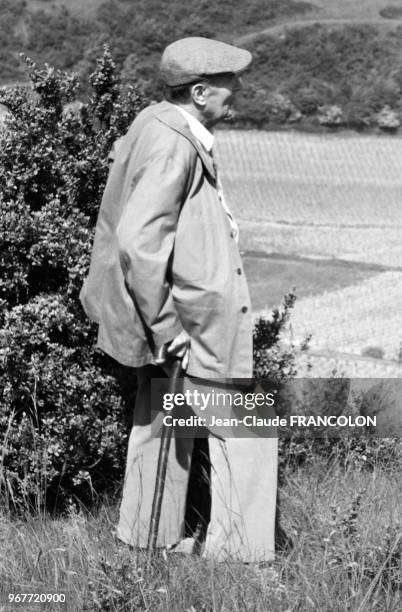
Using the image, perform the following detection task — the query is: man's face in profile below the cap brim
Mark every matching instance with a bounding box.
[194,74,242,127]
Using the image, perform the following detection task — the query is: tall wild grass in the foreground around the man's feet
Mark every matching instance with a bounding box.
[0,459,402,612]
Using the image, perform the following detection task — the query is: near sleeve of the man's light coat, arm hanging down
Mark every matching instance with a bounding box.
[117,134,192,347]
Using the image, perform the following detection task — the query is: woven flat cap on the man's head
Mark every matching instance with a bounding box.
[160,36,252,87]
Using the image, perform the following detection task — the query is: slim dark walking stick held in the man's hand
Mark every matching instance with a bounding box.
[148,350,181,555]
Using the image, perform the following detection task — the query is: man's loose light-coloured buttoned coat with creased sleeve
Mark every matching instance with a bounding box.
[80,102,252,378]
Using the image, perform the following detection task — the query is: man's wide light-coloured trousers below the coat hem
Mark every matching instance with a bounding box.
[117,366,278,562]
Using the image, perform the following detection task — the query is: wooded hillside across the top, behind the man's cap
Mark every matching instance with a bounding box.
[0,0,402,131]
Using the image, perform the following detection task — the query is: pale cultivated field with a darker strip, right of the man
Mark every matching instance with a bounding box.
[217,131,402,376]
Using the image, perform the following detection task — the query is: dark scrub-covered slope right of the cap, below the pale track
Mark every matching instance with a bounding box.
[238,24,401,129]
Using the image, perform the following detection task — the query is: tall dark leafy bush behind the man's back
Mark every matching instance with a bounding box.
[0,49,143,507]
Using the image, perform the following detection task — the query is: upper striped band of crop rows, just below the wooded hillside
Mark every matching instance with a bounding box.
[217,130,402,228]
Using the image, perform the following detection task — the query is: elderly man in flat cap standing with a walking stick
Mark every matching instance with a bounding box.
[81,37,276,561]
